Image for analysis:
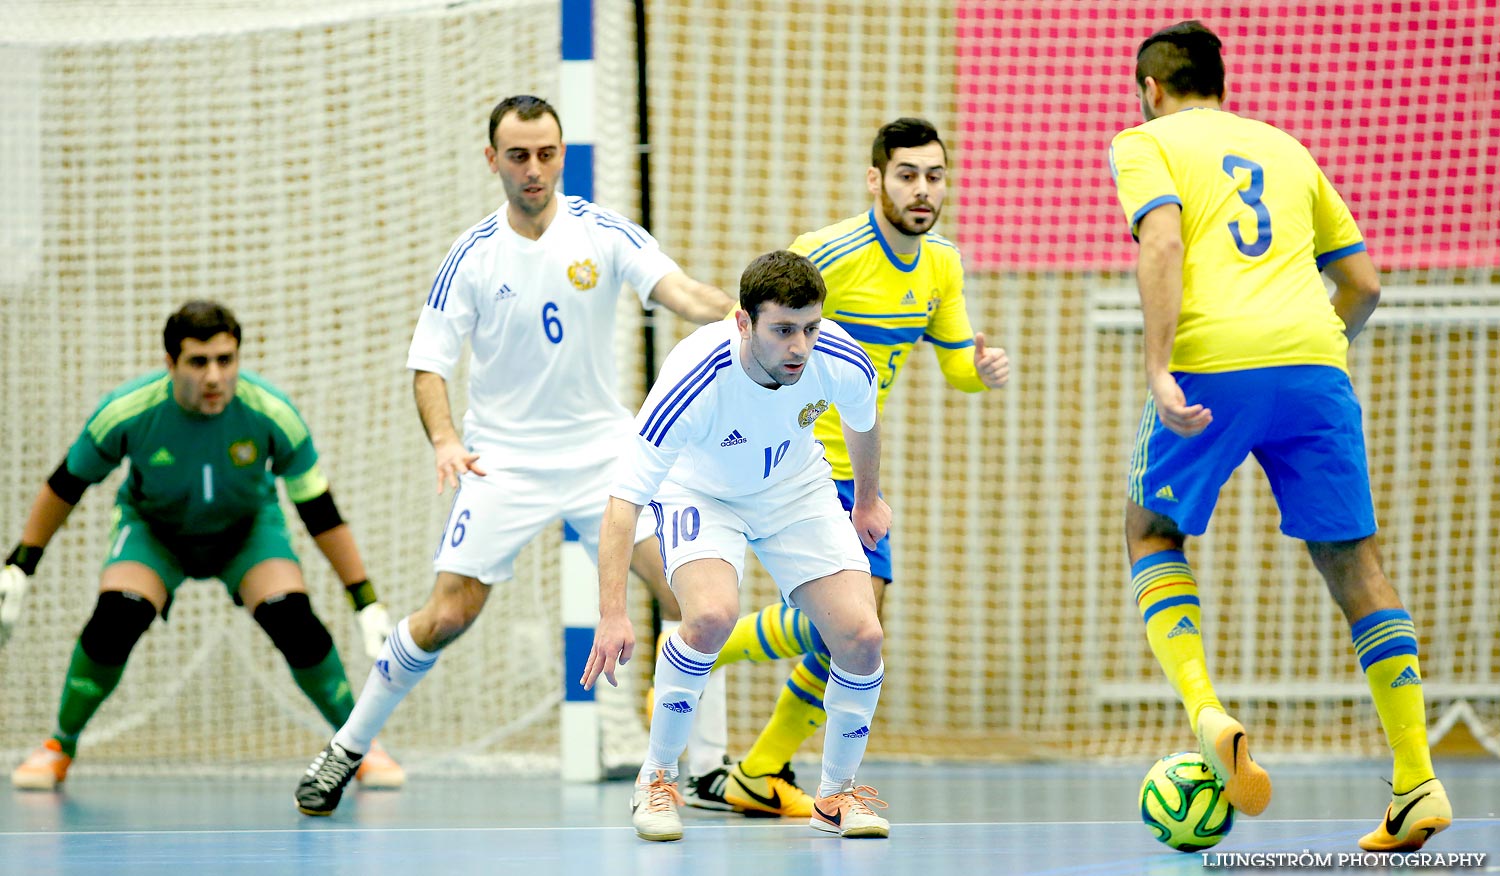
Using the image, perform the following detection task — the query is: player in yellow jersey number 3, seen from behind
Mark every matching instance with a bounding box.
[1110,21,1454,852]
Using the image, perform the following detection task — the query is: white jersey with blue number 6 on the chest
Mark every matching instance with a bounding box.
[407,198,678,468]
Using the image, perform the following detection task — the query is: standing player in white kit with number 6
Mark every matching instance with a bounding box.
[297,95,734,815]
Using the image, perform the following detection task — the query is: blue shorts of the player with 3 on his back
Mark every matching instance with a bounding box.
[1128,365,1376,542]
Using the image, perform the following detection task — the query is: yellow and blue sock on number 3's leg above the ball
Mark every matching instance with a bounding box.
[1131,551,1224,734]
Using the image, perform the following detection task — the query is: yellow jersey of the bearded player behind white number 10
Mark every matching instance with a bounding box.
[789,210,984,480]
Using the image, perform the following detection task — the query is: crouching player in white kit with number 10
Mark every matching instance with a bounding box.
[584,251,891,840]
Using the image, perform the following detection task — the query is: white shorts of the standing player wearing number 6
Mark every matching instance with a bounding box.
[432,452,656,584]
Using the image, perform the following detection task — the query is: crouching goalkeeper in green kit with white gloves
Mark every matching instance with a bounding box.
[0,302,404,791]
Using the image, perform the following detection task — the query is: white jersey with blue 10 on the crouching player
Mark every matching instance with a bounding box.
[611,320,878,506]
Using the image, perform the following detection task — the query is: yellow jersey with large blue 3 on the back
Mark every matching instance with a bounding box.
[1110,110,1365,374]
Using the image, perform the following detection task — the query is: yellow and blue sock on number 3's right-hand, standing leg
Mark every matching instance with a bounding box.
[1353,609,1434,794]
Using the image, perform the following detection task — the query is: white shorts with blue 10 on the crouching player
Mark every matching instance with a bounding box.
[642,476,870,605]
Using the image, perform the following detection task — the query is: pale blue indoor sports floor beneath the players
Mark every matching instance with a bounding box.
[0,759,1500,876]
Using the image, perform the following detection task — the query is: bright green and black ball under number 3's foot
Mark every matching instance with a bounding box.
[1140,752,1235,852]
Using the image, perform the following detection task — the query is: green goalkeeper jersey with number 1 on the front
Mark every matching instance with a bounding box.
[68,371,329,542]
